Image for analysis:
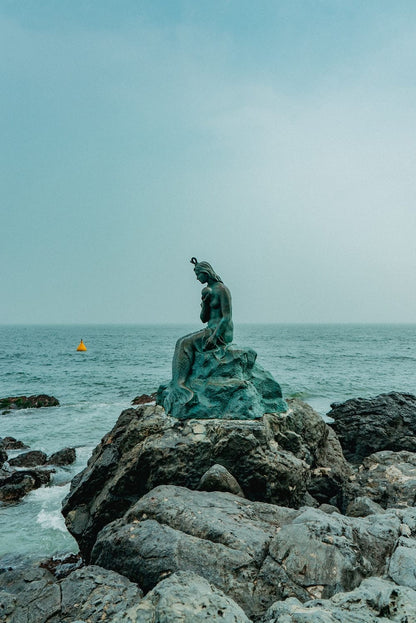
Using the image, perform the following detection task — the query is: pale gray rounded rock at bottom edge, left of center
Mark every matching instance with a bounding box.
[111,571,250,623]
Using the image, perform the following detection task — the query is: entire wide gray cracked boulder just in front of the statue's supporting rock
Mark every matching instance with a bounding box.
[91,486,403,617]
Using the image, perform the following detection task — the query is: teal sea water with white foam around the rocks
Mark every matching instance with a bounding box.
[0,325,416,564]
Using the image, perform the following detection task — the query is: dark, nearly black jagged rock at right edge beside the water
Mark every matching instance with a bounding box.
[328,392,416,463]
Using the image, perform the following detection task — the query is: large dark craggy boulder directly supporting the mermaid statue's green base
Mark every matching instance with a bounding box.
[63,400,349,560]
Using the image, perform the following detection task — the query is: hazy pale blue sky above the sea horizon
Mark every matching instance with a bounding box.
[0,0,416,323]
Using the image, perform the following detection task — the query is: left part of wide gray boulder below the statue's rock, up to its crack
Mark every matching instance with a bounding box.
[91,486,300,616]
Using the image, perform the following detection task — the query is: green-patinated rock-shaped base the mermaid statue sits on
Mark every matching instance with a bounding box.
[156,344,288,420]
